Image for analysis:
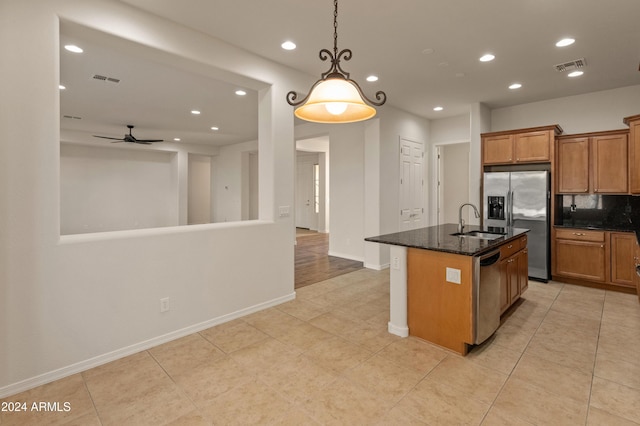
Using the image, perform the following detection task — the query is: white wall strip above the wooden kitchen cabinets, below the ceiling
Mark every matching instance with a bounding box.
[491,85,640,134]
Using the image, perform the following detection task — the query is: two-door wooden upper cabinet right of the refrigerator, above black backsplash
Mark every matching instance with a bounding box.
[556,130,629,194]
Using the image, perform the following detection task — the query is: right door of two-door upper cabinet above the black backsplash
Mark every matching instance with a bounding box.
[591,135,629,193]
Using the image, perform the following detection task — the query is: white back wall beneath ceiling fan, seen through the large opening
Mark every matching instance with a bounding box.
[60,144,178,235]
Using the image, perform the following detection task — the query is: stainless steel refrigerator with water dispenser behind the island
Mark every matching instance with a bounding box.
[483,171,551,282]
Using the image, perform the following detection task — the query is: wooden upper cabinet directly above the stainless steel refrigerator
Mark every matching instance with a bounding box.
[482,125,562,165]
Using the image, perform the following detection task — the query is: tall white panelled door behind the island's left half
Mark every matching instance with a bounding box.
[400,139,425,231]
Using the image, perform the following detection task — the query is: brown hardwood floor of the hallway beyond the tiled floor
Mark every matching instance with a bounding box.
[295,229,363,288]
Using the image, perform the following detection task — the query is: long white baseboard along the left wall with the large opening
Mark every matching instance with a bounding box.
[0,292,296,398]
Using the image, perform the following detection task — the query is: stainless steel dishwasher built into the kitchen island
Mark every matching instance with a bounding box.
[472,250,500,345]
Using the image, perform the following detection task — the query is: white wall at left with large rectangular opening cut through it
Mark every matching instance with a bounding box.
[0,0,304,397]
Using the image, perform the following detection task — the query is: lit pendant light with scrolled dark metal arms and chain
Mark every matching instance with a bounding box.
[287,0,387,123]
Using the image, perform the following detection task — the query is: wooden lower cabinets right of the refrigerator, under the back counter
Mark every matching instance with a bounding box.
[553,228,636,288]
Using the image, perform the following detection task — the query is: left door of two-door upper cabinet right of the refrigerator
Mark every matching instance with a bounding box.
[556,138,589,194]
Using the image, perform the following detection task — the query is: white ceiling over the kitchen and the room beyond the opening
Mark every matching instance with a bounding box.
[61,0,640,144]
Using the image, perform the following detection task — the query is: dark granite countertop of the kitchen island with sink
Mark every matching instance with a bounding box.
[365,223,529,256]
